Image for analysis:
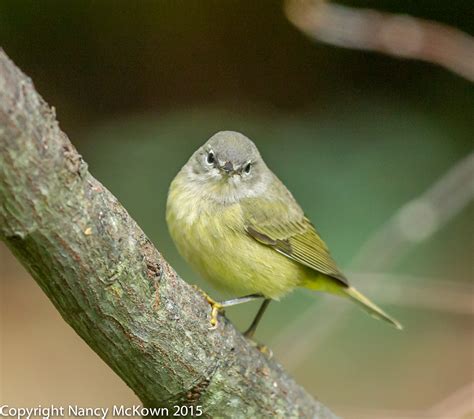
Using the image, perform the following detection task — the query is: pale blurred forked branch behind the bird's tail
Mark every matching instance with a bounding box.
[276,153,474,368]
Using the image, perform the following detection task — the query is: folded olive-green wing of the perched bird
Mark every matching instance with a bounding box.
[242,195,349,286]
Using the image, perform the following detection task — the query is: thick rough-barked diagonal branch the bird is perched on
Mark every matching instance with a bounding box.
[0,49,334,418]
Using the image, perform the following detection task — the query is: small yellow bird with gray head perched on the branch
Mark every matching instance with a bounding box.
[166,131,402,337]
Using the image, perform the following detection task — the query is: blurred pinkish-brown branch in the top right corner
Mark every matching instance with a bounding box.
[285,0,474,81]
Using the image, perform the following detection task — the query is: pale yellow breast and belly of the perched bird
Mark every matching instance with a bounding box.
[169,206,305,299]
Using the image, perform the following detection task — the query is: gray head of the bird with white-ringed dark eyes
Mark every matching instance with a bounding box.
[185,131,271,202]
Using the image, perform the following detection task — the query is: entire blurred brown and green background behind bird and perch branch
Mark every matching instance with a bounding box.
[0,0,474,418]
